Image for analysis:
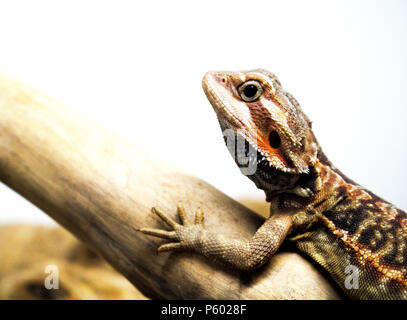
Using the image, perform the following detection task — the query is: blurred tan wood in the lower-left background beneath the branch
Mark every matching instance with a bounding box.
[0,225,146,300]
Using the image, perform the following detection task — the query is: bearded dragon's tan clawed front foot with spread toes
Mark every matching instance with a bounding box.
[139,201,204,252]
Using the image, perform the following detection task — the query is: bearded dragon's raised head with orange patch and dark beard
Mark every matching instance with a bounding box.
[202,69,318,202]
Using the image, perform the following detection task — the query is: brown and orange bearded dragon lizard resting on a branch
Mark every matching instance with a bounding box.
[141,69,407,299]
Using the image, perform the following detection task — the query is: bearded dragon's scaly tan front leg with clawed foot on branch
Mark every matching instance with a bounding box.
[140,202,292,270]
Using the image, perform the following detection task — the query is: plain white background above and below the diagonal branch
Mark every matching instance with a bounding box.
[0,0,407,223]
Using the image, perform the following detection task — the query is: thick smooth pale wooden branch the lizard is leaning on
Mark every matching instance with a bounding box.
[0,73,339,299]
